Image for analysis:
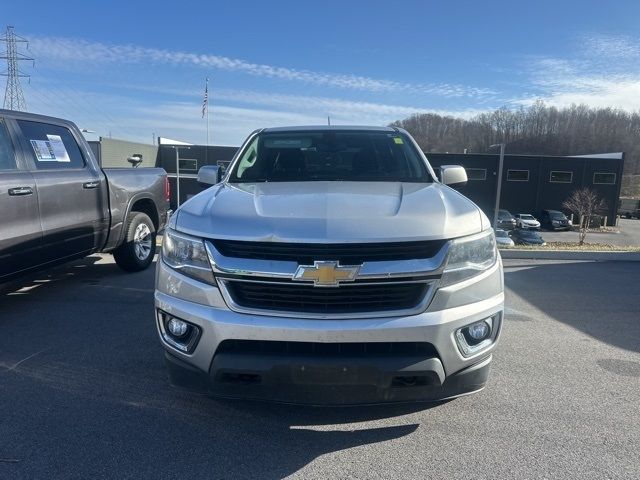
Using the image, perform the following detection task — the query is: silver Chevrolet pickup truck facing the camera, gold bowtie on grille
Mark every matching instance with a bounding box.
[155,126,504,404]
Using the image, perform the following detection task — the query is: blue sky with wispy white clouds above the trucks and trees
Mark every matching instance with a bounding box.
[0,0,640,145]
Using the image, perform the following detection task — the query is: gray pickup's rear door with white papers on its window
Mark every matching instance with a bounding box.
[17,120,108,261]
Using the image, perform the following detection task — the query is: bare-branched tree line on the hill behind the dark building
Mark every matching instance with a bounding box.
[392,101,640,193]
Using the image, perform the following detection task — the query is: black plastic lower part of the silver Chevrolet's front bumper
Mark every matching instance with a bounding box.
[165,352,491,405]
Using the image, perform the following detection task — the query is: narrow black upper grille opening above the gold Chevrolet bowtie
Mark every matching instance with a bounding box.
[212,240,446,265]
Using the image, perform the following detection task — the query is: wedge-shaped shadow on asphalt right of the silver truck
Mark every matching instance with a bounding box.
[505,261,640,352]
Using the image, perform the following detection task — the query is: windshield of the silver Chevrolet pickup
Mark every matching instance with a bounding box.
[229,130,432,183]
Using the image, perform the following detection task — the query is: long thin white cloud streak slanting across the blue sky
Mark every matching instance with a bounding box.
[31,36,496,98]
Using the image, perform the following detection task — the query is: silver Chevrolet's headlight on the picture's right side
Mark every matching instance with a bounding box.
[441,229,498,286]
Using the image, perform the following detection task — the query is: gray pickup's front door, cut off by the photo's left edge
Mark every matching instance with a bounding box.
[0,117,43,282]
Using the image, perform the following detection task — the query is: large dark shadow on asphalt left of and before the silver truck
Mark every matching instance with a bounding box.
[0,256,439,479]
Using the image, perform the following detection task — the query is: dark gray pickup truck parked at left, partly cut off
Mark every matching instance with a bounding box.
[0,110,169,283]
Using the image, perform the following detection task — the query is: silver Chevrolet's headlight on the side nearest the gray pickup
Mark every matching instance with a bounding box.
[162,228,216,285]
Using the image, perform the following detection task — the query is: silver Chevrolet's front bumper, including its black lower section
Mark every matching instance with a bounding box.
[155,261,504,404]
